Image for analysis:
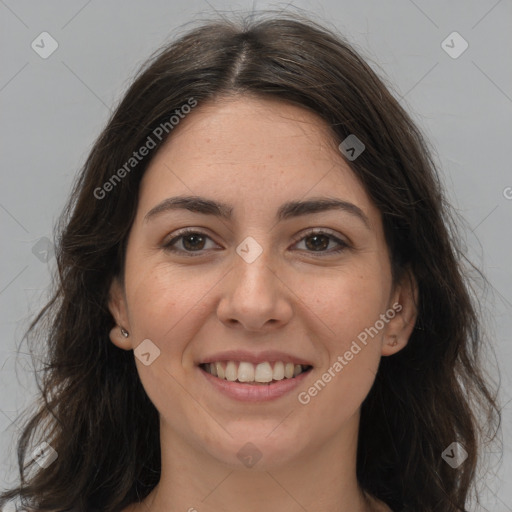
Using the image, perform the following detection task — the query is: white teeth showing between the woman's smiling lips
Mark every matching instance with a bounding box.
[199,361,313,385]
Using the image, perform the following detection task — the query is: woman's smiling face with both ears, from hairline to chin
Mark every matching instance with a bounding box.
[110,96,413,467]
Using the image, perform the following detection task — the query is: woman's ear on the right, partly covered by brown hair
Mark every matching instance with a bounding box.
[382,268,418,356]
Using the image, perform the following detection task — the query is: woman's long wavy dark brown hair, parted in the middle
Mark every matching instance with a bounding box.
[2,9,500,512]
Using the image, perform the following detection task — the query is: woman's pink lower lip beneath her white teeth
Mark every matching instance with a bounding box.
[198,367,311,402]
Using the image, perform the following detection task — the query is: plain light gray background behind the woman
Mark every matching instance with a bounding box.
[0,0,512,512]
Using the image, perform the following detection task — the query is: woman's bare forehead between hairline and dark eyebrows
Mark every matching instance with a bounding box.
[140,96,379,226]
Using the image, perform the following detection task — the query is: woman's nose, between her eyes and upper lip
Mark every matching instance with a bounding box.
[217,250,293,332]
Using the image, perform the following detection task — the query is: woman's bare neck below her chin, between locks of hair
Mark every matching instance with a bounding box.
[130,417,389,512]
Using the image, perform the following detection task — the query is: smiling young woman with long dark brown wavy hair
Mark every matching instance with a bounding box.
[3,9,499,512]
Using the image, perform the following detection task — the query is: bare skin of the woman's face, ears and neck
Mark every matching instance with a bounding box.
[109,96,417,512]
